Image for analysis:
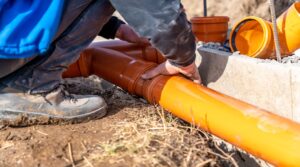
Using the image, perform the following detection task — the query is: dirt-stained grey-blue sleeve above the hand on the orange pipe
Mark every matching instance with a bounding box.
[110,0,196,66]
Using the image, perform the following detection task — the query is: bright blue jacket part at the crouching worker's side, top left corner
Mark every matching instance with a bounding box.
[0,0,64,59]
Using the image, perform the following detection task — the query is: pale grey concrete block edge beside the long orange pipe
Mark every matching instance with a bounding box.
[197,48,300,123]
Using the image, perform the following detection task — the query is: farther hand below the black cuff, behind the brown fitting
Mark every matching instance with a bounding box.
[116,24,150,45]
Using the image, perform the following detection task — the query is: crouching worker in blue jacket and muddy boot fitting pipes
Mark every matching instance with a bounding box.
[0,0,201,126]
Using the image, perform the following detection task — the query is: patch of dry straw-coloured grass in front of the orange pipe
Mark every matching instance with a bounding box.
[82,106,235,167]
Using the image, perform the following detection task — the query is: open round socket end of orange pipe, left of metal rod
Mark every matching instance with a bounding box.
[229,16,276,58]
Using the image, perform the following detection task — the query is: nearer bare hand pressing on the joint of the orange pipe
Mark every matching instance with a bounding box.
[142,60,202,84]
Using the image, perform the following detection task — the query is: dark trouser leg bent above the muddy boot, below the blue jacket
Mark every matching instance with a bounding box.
[0,0,115,94]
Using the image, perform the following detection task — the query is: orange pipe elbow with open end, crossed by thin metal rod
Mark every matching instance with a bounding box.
[229,2,300,58]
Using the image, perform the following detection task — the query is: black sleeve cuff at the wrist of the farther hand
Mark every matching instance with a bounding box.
[98,16,125,39]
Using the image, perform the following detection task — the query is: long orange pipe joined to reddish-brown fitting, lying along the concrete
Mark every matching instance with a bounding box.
[64,41,300,166]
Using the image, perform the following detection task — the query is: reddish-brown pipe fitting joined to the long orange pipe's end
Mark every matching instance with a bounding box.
[63,43,169,104]
